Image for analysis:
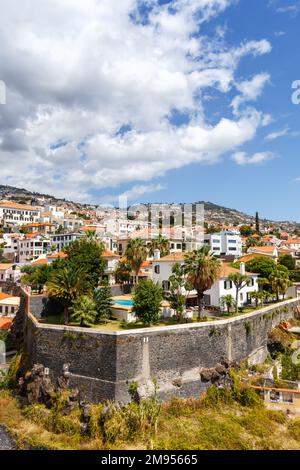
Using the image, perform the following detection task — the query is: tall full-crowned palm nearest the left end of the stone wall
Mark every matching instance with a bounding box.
[47,266,87,324]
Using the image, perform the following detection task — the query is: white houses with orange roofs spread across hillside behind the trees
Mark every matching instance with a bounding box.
[0,201,300,330]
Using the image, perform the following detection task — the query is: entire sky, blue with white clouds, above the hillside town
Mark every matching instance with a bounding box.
[0,0,300,221]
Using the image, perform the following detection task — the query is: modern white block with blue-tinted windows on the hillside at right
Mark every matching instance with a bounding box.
[204,231,242,257]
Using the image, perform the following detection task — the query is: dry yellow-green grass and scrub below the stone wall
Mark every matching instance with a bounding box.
[0,391,300,450]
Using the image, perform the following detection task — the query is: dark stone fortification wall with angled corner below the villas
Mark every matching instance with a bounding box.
[22,290,299,402]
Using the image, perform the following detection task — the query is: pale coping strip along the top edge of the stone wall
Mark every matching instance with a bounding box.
[23,291,300,336]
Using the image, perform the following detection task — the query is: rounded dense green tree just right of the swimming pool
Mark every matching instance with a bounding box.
[133,280,163,326]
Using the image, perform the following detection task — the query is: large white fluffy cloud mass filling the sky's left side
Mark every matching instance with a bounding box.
[0,0,271,200]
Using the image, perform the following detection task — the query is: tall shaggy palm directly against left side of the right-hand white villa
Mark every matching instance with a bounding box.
[185,245,221,320]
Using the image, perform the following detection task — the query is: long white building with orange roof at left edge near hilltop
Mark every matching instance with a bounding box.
[0,201,40,227]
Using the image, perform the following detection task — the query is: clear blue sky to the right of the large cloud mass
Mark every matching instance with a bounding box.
[139,0,300,221]
